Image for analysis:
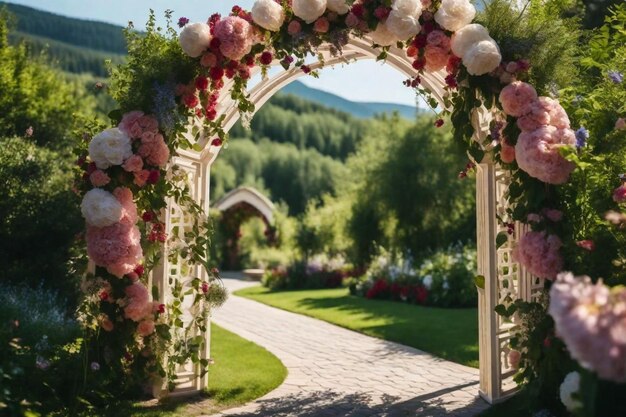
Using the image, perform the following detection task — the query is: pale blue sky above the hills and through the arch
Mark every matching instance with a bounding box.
[8,0,415,105]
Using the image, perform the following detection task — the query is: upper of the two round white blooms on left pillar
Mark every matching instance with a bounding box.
[89,127,133,169]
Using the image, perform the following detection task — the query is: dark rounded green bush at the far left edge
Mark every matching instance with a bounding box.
[0,138,83,299]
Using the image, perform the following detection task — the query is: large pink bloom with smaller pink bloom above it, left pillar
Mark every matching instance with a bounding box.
[86,188,143,278]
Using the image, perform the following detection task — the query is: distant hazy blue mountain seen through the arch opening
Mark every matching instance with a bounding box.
[280,81,421,120]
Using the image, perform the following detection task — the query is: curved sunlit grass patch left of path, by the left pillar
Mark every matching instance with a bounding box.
[116,324,287,417]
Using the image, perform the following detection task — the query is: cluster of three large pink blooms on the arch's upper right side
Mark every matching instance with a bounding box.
[500,81,576,184]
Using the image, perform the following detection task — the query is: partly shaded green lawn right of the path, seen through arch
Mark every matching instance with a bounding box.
[235,287,478,368]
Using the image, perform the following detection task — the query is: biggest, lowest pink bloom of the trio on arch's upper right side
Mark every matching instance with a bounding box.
[515,126,576,184]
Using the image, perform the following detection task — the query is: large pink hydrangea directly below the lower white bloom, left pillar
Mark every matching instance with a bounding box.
[86,222,143,272]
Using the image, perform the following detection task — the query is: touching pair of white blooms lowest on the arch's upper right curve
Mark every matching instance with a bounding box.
[444,23,502,75]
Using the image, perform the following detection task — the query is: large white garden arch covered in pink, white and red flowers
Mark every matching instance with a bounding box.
[72,0,620,410]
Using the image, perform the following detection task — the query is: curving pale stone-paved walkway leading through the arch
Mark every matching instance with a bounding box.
[213,279,487,417]
